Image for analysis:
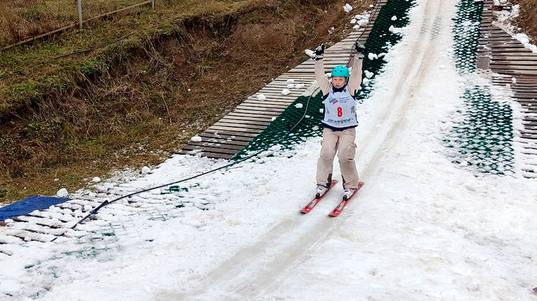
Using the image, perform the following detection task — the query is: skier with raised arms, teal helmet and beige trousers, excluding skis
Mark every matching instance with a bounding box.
[314,42,365,199]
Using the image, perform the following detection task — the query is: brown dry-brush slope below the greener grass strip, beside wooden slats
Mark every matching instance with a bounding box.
[0,0,371,202]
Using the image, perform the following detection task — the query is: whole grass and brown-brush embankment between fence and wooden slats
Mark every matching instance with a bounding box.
[0,0,372,202]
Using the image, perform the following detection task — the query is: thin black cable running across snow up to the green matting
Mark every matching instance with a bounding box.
[51,0,379,242]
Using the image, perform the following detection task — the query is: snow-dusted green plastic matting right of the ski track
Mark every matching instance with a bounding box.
[444,0,514,175]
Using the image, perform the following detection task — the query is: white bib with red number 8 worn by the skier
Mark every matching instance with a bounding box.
[322,87,358,128]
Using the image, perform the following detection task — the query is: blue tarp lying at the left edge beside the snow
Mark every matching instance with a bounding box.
[0,195,69,221]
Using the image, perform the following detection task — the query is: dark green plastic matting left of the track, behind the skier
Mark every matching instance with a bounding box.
[233,0,415,159]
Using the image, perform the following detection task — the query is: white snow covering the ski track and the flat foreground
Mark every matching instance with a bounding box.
[0,0,537,301]
